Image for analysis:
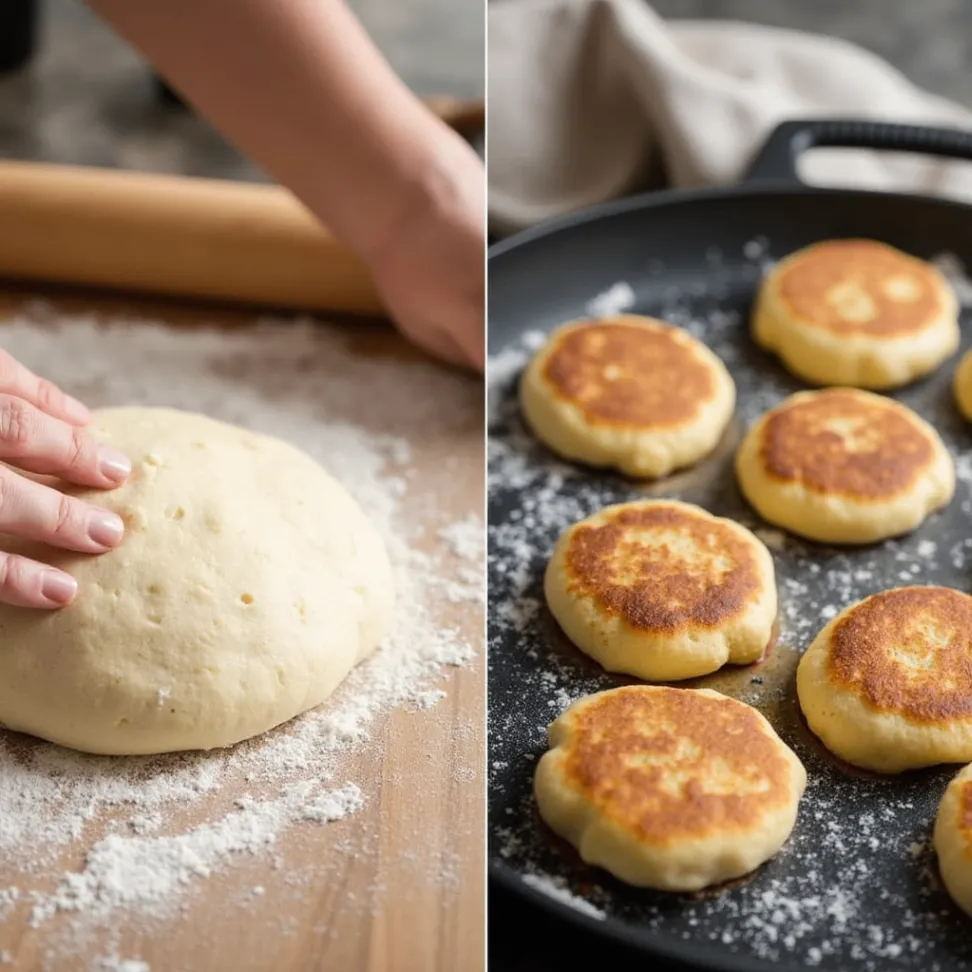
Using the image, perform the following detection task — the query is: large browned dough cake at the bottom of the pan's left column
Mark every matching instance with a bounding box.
[534,685,807,891]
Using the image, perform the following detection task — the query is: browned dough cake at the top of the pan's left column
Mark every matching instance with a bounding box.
[520,316,736,479]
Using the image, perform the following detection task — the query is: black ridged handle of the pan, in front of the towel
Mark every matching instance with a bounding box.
[743,119,972,185]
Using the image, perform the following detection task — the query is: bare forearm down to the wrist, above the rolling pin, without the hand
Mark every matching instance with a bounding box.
[85,0,469,259]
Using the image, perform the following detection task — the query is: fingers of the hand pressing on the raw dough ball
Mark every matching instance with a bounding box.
[0,351,131,608]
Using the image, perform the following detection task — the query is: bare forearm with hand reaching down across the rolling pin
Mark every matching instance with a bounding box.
[83,0,486,368]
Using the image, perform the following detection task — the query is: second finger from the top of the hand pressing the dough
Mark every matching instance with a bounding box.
[0,392,132,489]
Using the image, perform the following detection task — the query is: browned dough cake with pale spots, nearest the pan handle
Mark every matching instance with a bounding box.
[752,240,959,388]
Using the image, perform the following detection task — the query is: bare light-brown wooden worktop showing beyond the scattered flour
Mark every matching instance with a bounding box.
[0,287,485,972]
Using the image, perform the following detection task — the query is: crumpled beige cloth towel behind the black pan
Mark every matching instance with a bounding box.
[488,0,972,235]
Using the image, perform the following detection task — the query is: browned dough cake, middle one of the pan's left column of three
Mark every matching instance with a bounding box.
[544,500,776,682]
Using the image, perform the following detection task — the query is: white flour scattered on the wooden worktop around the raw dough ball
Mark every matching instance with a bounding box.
[0,306,483,972]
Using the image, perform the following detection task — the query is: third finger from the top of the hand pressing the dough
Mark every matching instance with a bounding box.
[0,467,125,554]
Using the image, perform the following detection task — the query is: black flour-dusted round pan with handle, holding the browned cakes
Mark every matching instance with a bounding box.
[489,121,972,972]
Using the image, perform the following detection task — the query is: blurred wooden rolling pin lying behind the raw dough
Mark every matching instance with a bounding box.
[0,99,477,314]
